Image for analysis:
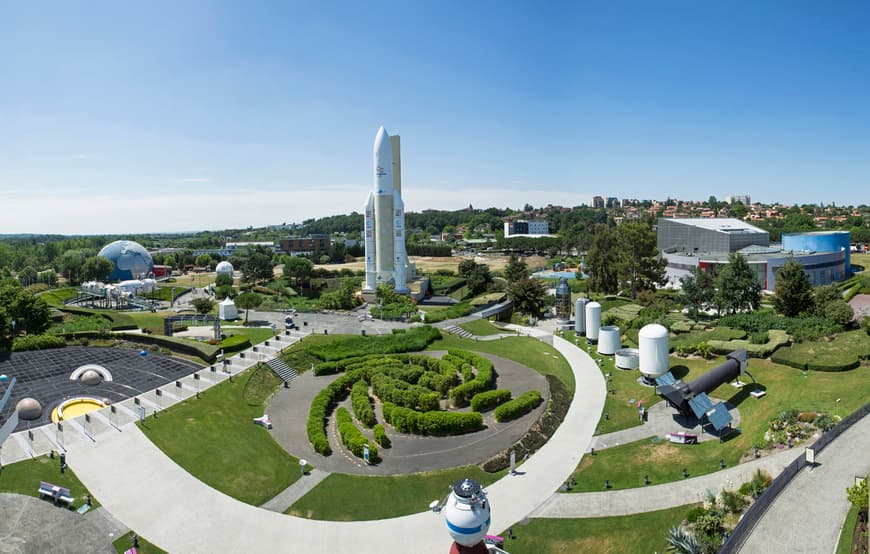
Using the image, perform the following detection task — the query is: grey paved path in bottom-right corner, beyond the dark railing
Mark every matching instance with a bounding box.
[741,416,870,554]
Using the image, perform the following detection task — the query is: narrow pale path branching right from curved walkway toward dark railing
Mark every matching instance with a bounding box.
[533,448,804,518]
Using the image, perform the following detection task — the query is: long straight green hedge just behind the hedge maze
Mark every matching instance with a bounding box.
[308,325,441,362]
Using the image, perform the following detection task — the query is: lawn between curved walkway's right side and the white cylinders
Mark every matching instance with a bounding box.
[565,331,658,434]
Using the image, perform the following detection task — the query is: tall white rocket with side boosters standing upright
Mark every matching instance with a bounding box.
[363,123,409,293]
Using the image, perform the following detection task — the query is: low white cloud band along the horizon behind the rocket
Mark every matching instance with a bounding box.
[0,186,591,234]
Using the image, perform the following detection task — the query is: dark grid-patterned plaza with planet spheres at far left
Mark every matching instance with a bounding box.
[0,346,201,431]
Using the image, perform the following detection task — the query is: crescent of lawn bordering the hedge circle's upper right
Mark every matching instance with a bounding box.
[428,335,576,395]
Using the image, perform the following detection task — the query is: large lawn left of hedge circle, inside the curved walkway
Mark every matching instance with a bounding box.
[138,366,299,506]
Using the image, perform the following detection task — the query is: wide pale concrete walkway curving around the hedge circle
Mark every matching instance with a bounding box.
[67,337,606,554]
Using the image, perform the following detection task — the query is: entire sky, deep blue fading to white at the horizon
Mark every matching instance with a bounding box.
[0,0,870,233]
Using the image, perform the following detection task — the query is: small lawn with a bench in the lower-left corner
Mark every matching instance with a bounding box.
[0,456,100,509]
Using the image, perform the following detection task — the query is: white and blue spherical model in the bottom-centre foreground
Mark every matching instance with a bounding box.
[444,479,490,547]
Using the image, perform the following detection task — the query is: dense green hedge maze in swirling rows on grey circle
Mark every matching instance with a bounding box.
[307,349,541,462]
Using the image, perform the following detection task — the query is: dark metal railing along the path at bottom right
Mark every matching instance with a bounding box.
[719,403,870,554]
